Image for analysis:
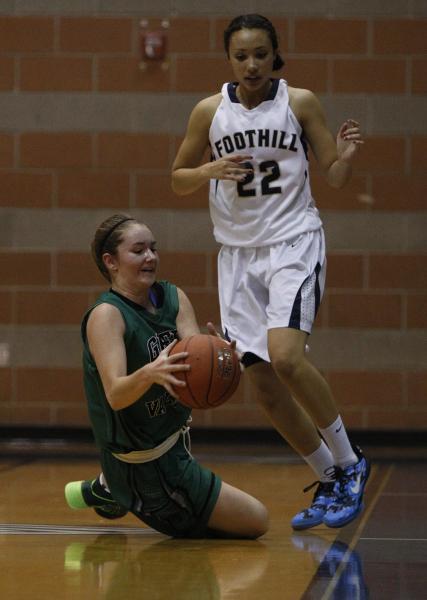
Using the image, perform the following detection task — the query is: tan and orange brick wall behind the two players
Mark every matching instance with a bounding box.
[0,0,427,430]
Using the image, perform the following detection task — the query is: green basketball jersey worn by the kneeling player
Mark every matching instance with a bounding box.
[82,281,191,452]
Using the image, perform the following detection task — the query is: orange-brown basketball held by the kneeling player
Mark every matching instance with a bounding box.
[170,333,244,409]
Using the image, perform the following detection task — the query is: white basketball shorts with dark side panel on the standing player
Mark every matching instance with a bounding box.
[218,229,326,362]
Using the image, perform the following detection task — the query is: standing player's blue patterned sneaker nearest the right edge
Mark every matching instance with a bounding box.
[323,446,371,527]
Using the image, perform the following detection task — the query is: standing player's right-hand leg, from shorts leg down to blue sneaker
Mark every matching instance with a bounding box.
[266,231,369,526]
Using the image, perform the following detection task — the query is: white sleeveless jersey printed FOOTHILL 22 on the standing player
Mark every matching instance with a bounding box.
[209,79,322,246]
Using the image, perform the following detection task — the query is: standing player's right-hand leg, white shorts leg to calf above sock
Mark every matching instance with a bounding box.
[266,231,338,428]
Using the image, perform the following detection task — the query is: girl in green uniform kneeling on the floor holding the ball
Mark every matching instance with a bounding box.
[65,215,268,538]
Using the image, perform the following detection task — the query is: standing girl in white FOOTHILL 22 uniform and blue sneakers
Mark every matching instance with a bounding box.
[172,14,369,529]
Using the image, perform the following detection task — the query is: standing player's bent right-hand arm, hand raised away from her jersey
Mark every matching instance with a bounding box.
[291,88,363,188]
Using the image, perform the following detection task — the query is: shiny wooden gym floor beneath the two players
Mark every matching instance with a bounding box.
[0,440,427,600]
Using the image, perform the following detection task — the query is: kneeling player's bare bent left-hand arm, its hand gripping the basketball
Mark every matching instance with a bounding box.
[87,303,187,410]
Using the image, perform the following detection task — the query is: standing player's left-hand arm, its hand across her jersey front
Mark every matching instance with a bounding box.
[172,94,251,195]
